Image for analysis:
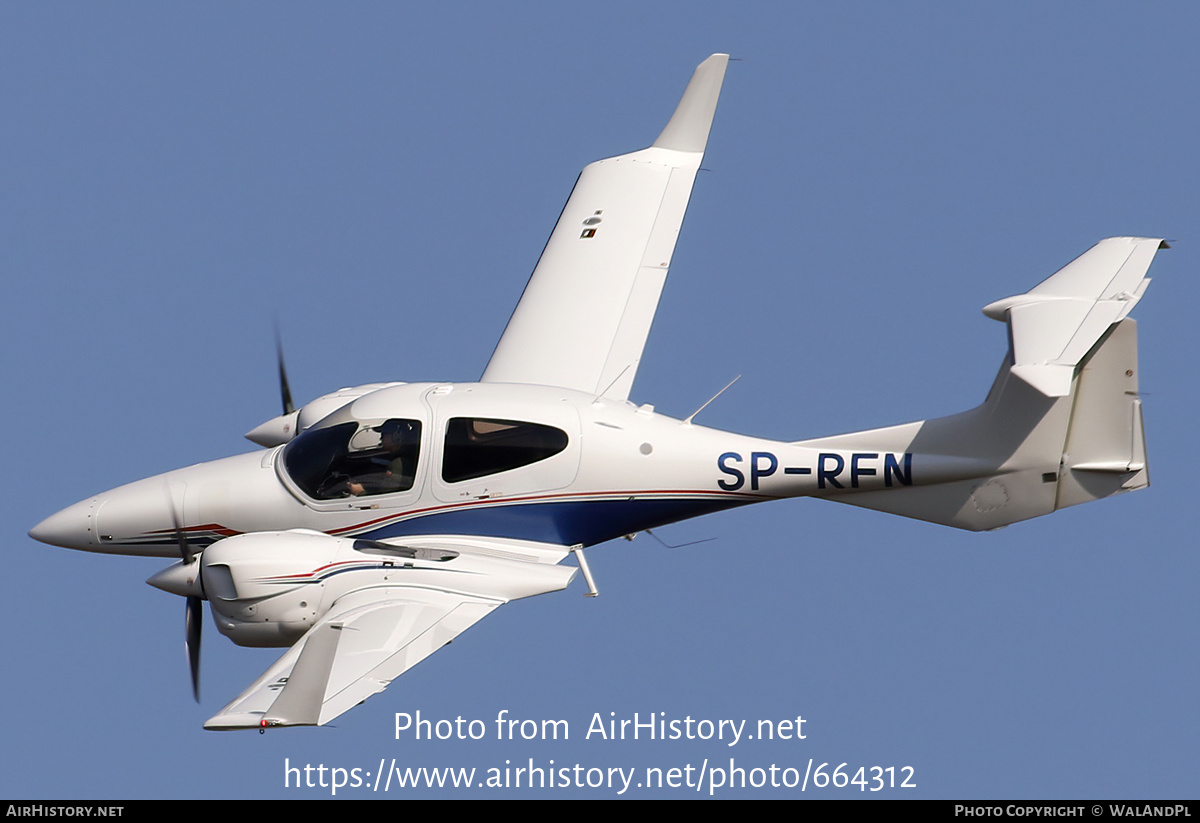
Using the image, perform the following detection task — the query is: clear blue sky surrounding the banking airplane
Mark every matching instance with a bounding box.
[0,2,1200,798]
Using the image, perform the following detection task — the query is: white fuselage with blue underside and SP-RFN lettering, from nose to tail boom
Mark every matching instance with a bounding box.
[35,384,919,557]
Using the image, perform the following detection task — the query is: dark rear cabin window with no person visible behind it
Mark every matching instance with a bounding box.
[442,417,566,483]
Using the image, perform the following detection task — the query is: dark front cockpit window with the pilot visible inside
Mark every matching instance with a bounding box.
[283,417,421,500]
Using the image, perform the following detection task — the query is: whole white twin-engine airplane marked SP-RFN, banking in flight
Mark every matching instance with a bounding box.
[30,54,1165,729]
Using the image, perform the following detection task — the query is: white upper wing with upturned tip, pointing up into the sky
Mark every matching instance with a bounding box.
[482,54,728,400]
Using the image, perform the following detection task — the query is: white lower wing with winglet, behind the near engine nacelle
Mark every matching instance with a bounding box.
[204,544,576,729]
